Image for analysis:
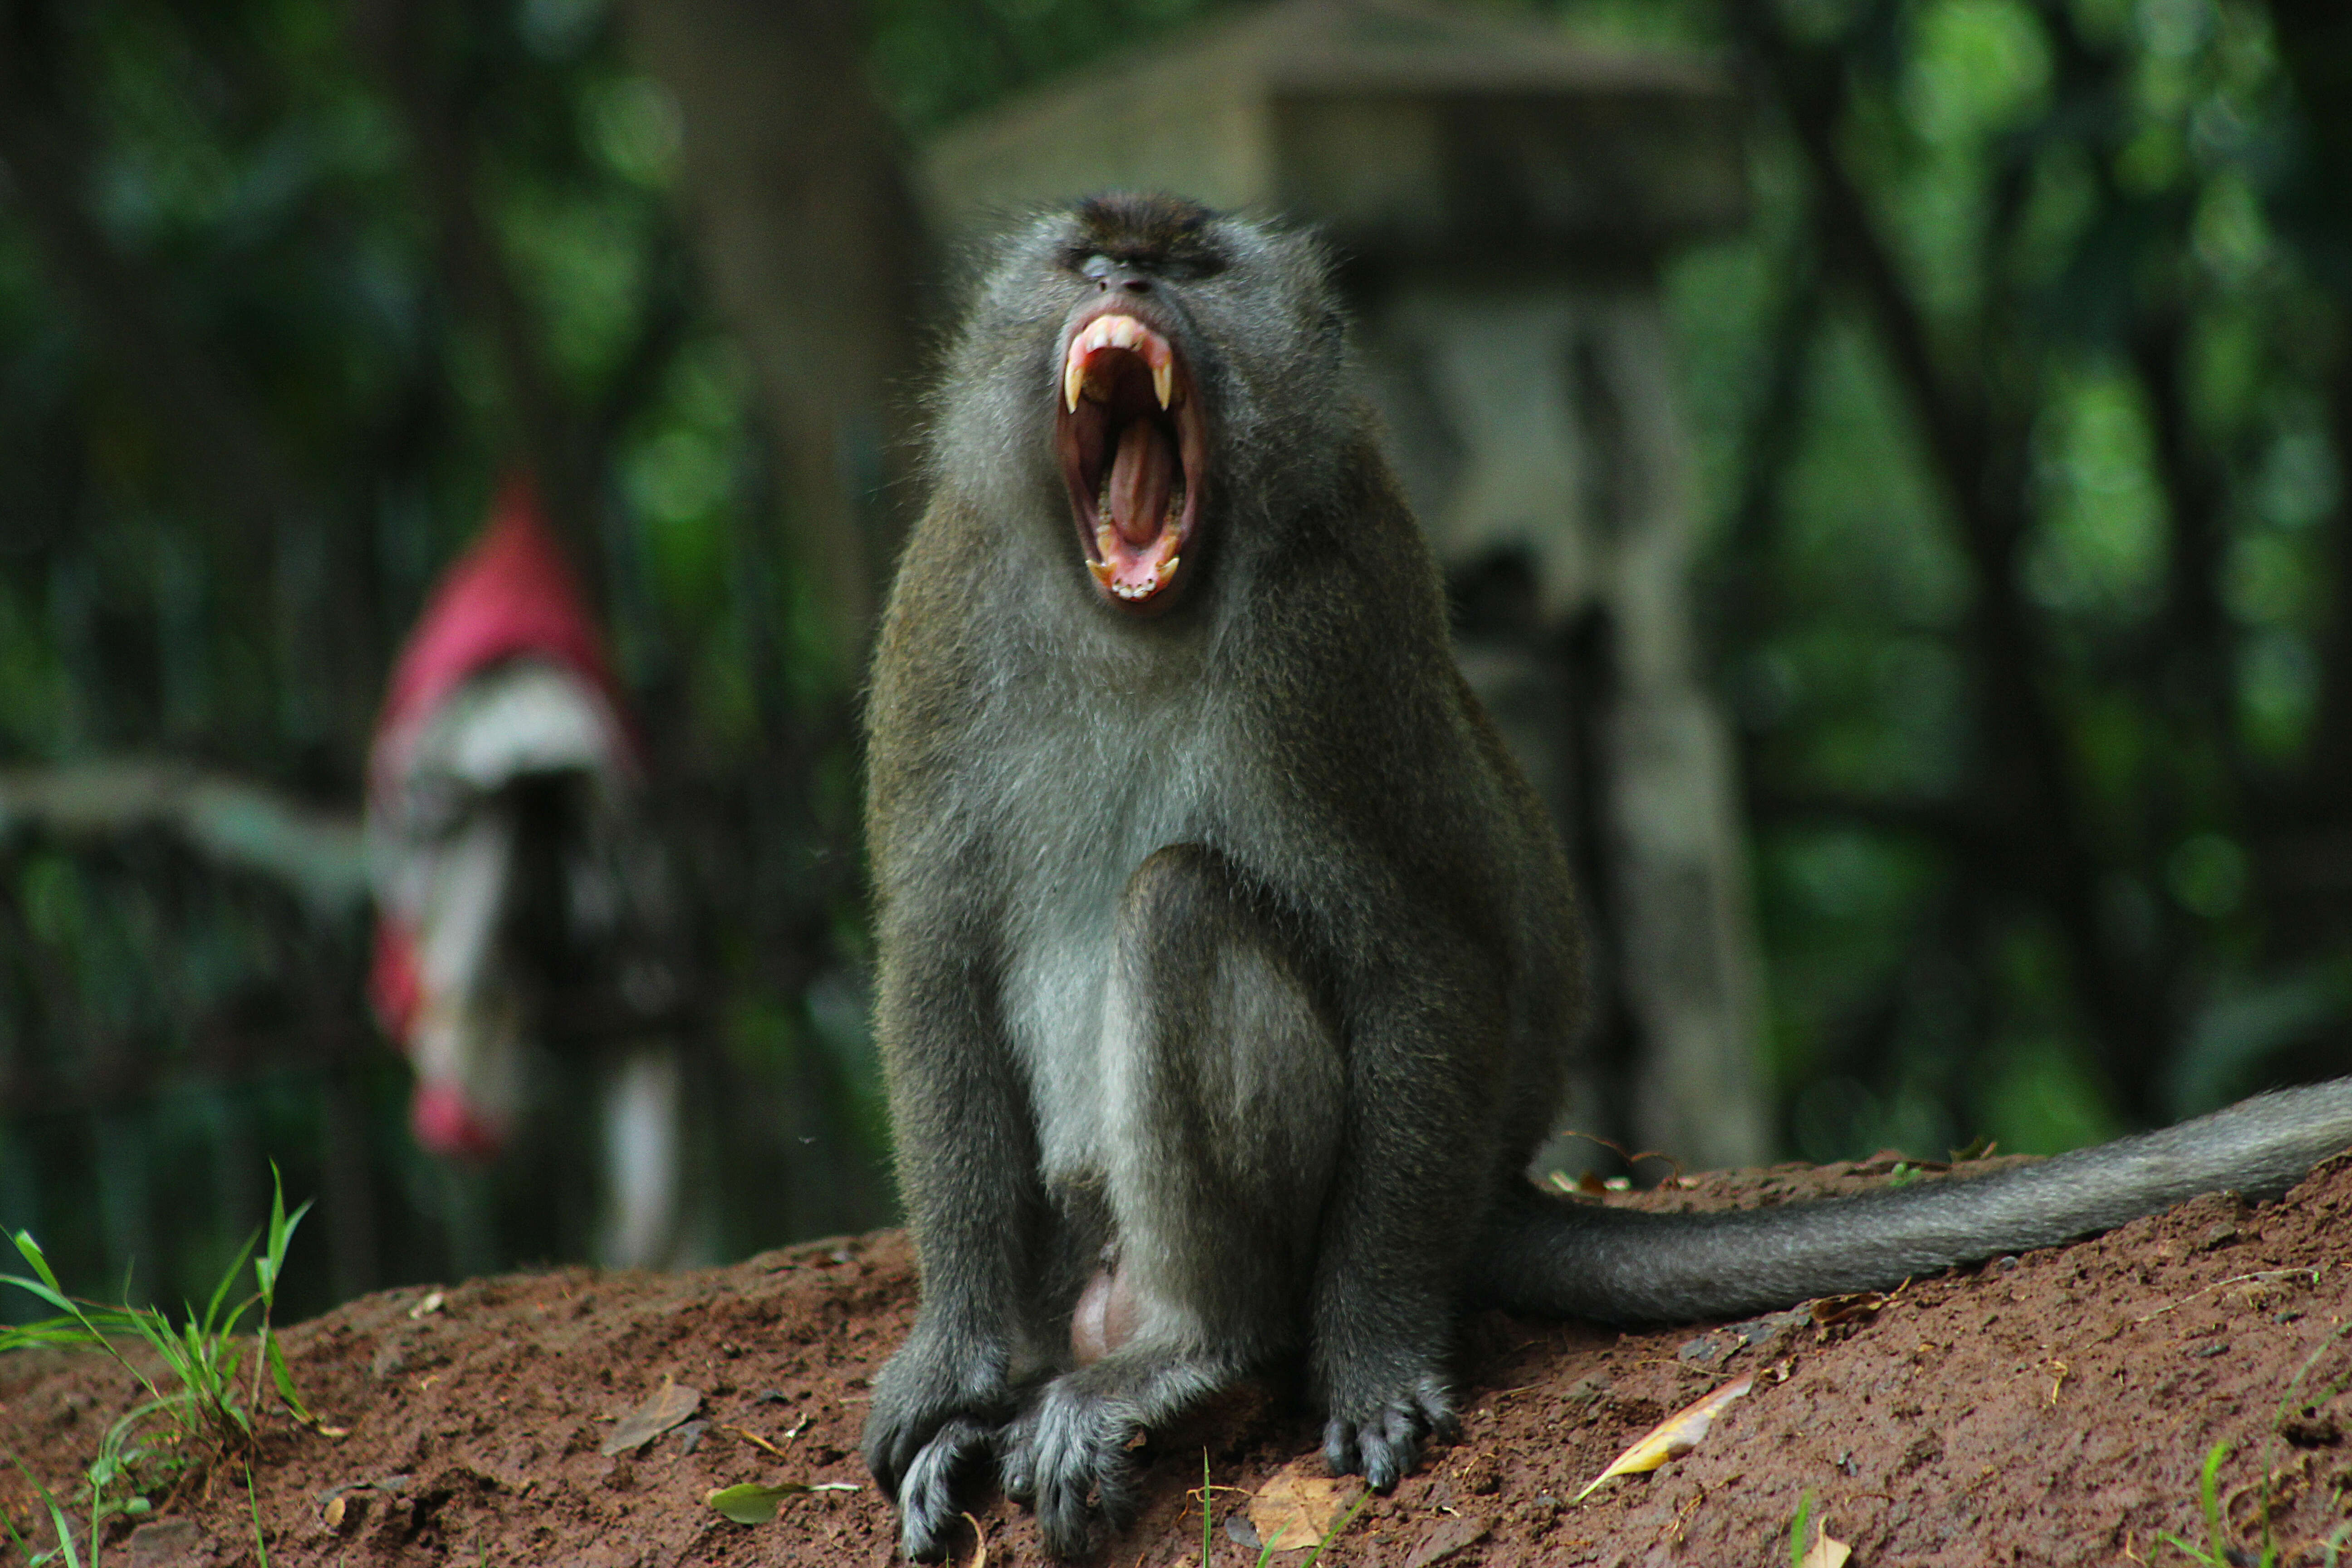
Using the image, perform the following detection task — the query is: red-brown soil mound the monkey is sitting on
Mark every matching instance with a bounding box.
[0,1161,2352,1568]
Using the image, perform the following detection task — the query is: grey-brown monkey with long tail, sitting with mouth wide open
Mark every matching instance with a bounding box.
[866,197,2352,1556]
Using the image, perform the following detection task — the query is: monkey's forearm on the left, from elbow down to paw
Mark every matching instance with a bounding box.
[863,903,1049,1556]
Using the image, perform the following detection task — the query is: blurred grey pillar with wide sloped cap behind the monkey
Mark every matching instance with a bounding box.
[922,0,1771,1168]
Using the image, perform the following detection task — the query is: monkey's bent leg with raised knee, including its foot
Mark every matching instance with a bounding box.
[1002,844,1345,1556]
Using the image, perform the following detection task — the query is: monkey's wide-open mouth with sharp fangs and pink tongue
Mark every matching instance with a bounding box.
[1054,310,1206,609]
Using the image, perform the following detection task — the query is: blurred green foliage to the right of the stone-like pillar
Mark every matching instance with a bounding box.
[1672,0,2352,1159]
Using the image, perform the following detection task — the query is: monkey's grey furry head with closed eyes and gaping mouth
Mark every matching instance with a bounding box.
[938,195,1359,616]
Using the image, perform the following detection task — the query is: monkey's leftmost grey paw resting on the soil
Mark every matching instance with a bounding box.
[863,1321,1014,1558]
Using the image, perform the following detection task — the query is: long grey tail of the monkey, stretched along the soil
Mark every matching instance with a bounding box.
[1470,1079,2352,1323]
